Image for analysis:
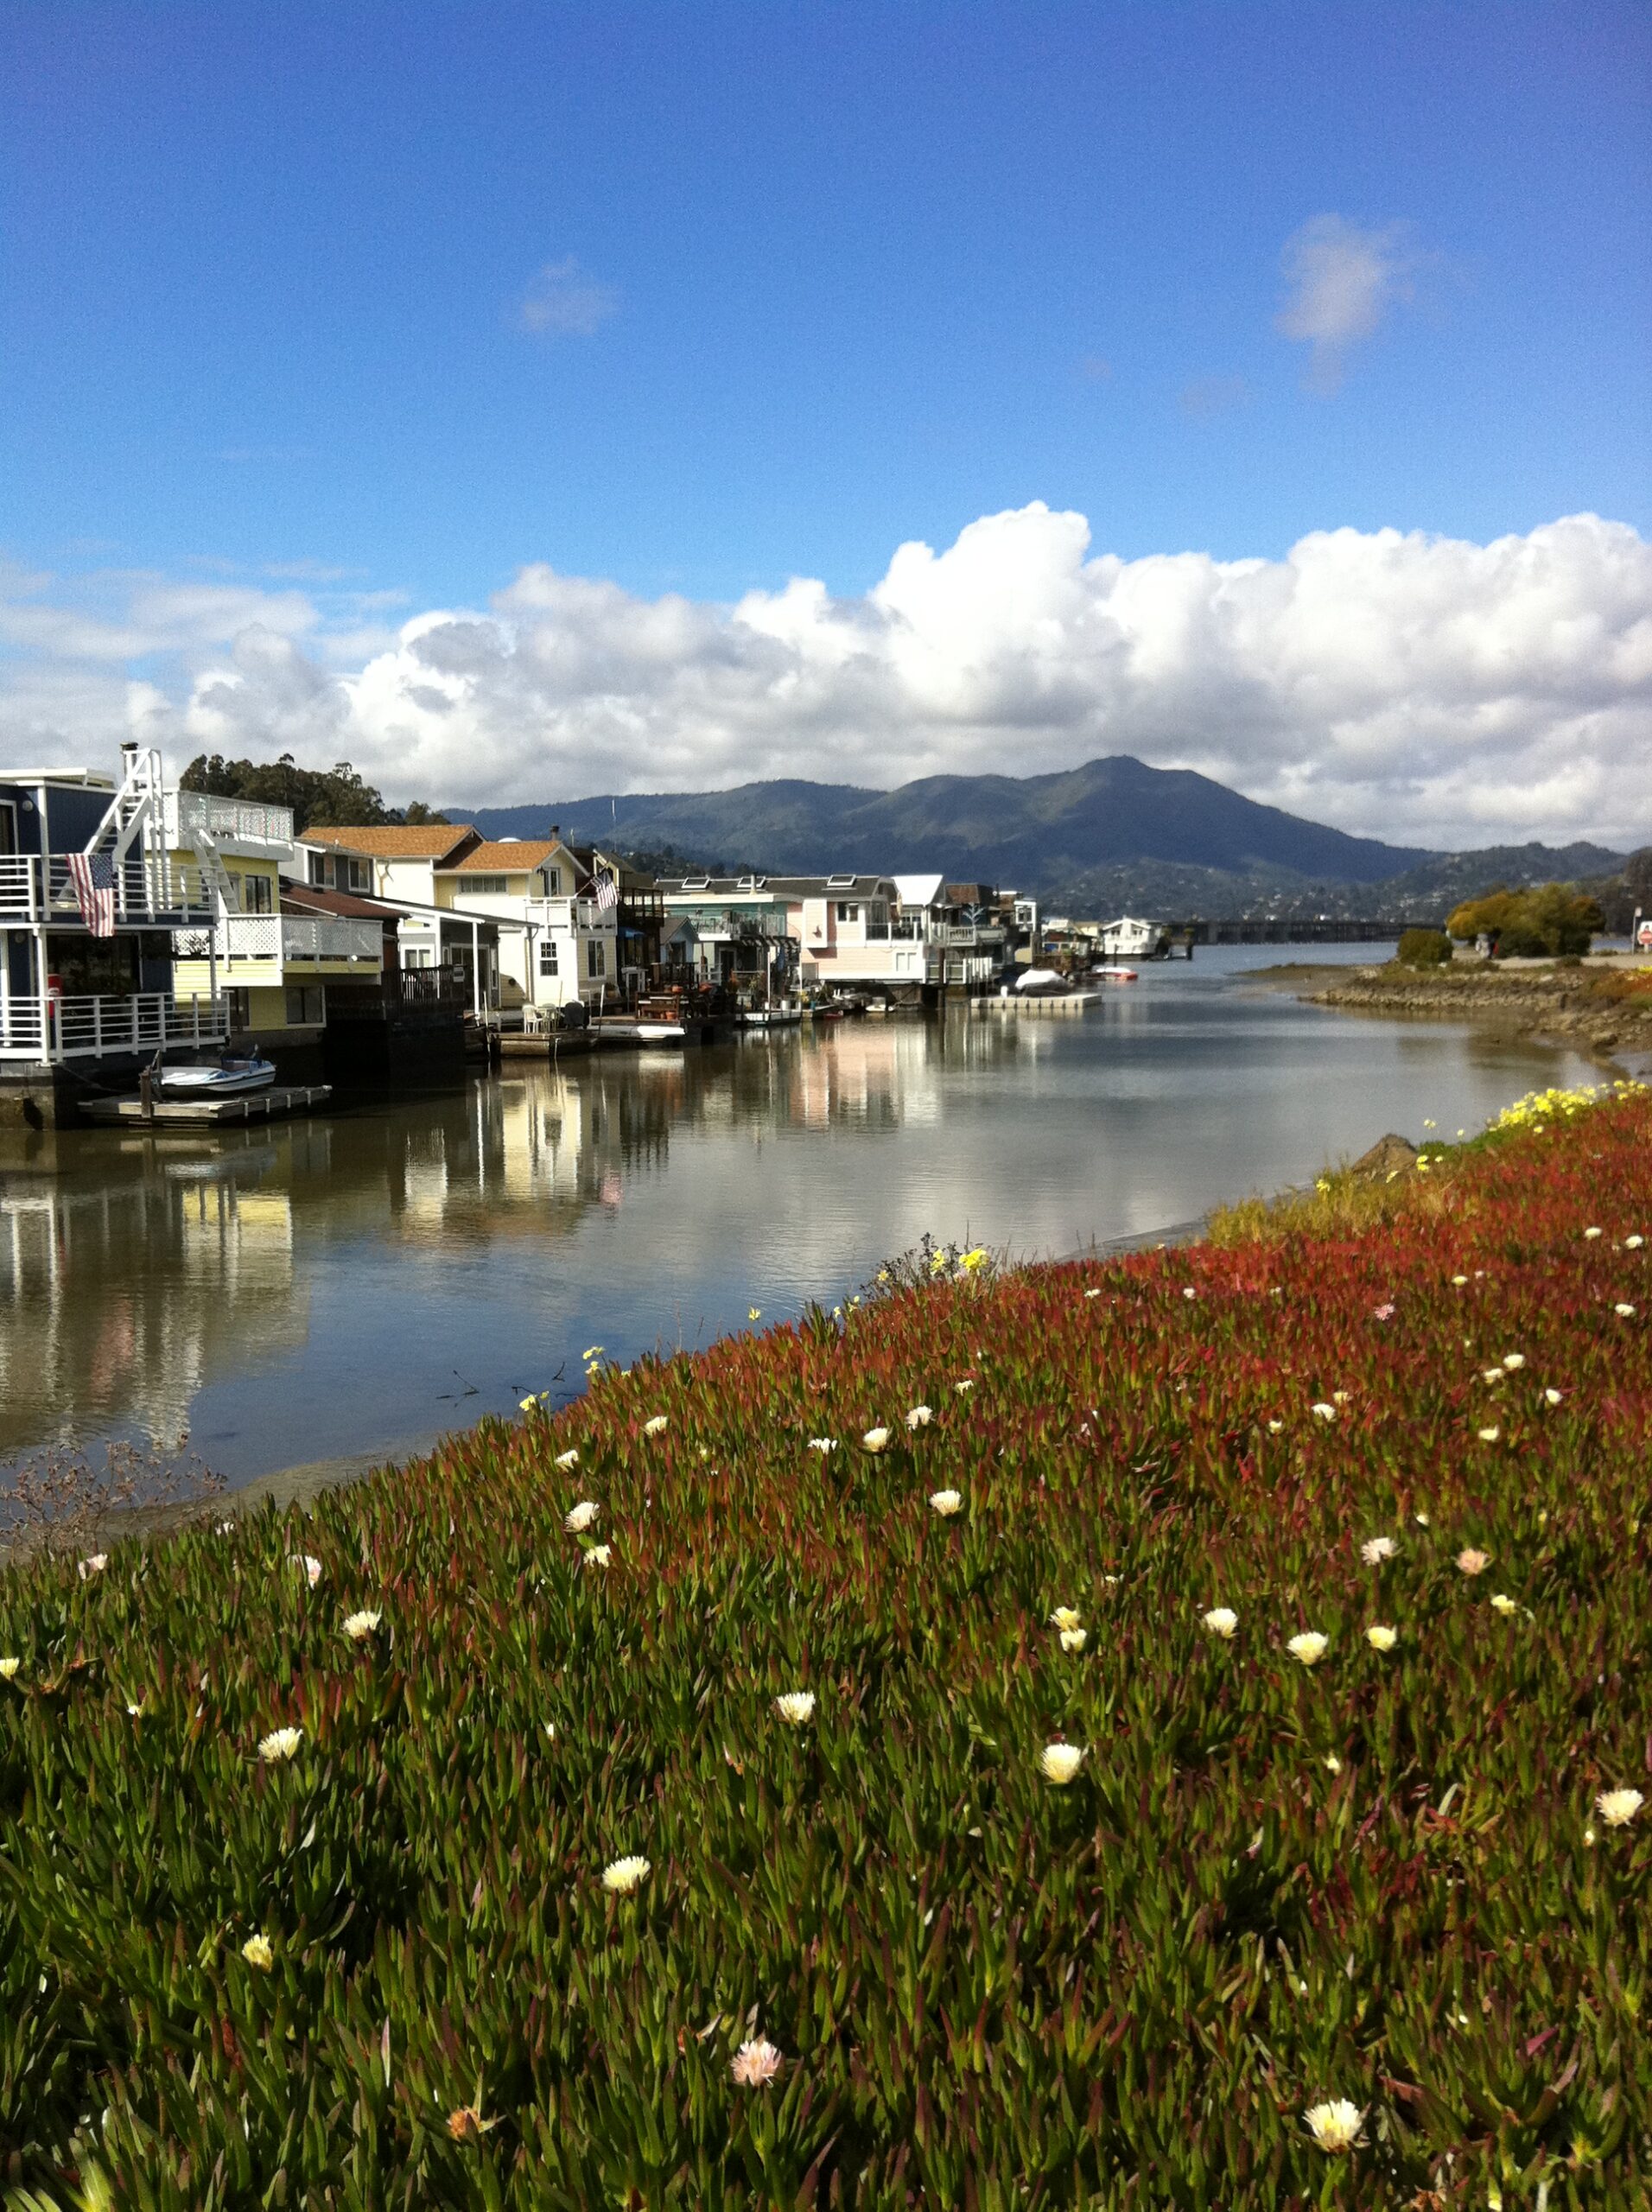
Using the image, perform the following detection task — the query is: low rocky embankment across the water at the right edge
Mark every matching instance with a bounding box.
[1298,963,1652,1051]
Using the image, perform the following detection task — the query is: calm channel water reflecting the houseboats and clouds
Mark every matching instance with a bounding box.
[0,947,1592,1482]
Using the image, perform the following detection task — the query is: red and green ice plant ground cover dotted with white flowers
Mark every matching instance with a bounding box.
[0,1093,1652,2212]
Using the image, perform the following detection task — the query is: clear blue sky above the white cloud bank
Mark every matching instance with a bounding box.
[0,0,1652,844]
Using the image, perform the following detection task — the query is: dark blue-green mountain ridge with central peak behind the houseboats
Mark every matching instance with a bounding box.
[447,754,1619,918]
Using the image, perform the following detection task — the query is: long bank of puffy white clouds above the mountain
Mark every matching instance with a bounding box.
[0,502,1652,845]
